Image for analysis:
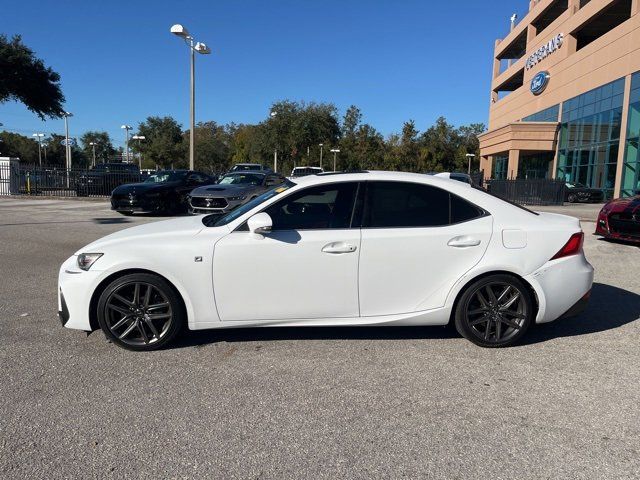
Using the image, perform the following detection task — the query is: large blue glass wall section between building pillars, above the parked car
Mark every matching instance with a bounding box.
[556,78,624,198]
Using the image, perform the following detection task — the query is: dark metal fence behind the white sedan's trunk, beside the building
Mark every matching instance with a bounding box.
[487,178,566,205]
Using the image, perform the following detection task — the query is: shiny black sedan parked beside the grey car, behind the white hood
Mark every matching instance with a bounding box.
[111,170,216,215]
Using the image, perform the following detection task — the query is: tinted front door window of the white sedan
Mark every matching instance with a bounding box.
[265,182,358,230]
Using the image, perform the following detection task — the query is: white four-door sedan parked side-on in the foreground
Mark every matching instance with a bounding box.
[58,172,593,350]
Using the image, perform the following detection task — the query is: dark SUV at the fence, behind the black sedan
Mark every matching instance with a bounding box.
[76,163,141,197]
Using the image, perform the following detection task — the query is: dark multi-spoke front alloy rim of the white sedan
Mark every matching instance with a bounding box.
[104,282,174,346]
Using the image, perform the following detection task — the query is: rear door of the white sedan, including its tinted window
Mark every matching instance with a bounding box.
[359,182,493,317]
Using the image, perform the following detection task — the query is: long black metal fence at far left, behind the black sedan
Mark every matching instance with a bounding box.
[0,164,142,197]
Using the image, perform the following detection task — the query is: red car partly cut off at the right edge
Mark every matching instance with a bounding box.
[596,195,640,243]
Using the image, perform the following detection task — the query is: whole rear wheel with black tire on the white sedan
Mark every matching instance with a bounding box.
[455,274,535,348]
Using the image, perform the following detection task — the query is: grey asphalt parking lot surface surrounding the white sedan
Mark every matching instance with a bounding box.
[0,198,640,479]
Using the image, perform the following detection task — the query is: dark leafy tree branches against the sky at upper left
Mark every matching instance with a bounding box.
[0,35,64,120]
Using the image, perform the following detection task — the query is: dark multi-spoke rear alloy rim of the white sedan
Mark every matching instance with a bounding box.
[466,282,529,344]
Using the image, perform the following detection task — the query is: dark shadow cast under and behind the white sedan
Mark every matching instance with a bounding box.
[172,283,640,348]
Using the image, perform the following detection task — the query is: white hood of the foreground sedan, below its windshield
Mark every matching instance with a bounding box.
[76,216,220,255]
